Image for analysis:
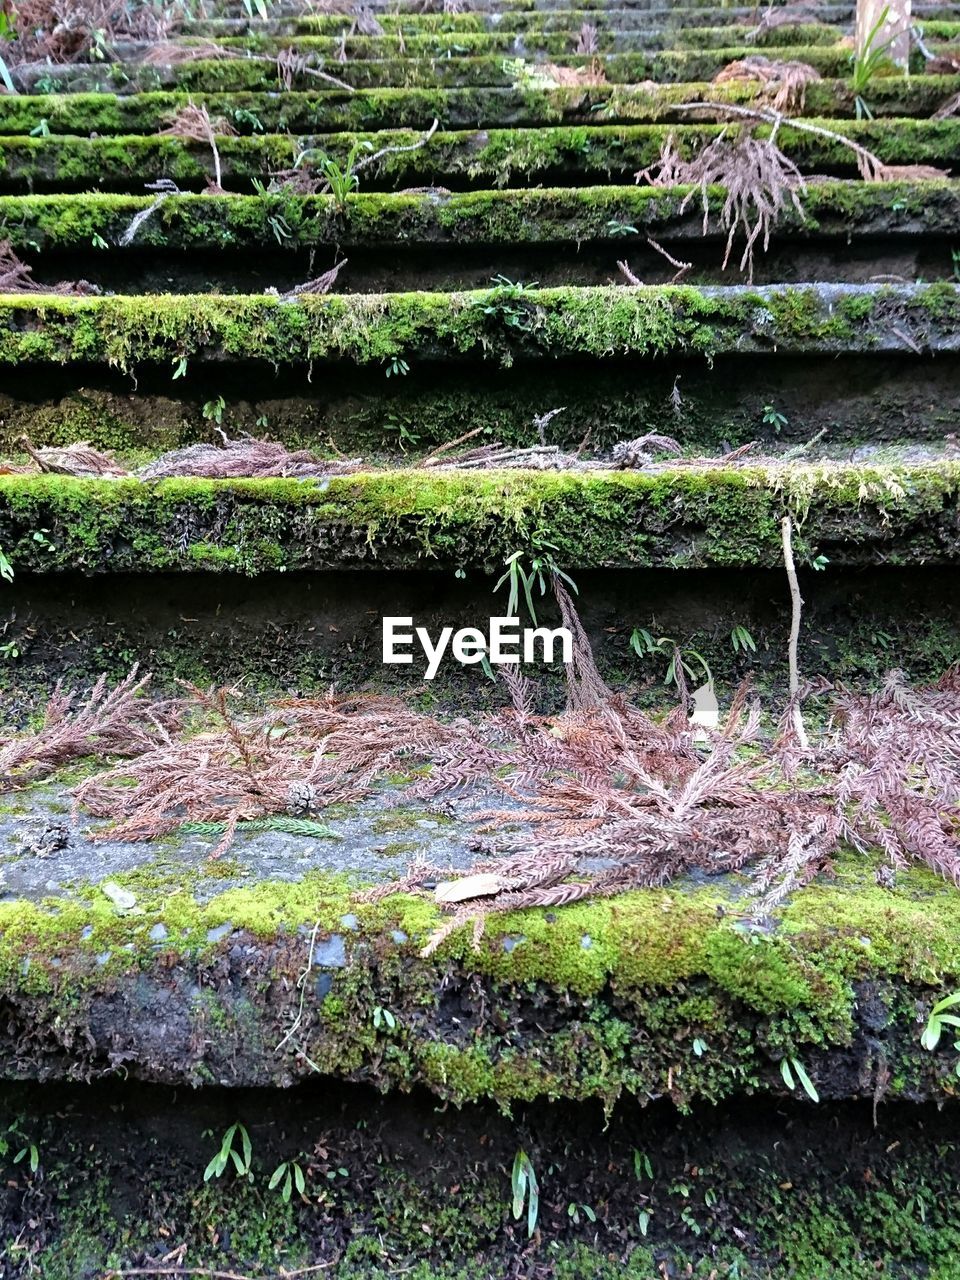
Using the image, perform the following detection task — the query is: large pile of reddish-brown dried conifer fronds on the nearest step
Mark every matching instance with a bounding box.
[13,582,960,952]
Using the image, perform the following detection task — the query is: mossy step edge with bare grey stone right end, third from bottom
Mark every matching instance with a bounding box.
[0,283,960,371]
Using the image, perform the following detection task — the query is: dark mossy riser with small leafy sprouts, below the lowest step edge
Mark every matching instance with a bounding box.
[13,1090,960,1280]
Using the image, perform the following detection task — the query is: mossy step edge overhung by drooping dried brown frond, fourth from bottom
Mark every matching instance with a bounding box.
[0,179,960,256]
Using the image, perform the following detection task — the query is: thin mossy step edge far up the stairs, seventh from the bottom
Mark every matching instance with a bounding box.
[7,45,875,95]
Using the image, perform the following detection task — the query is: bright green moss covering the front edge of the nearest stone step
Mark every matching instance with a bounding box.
[0,844,960,1106]
